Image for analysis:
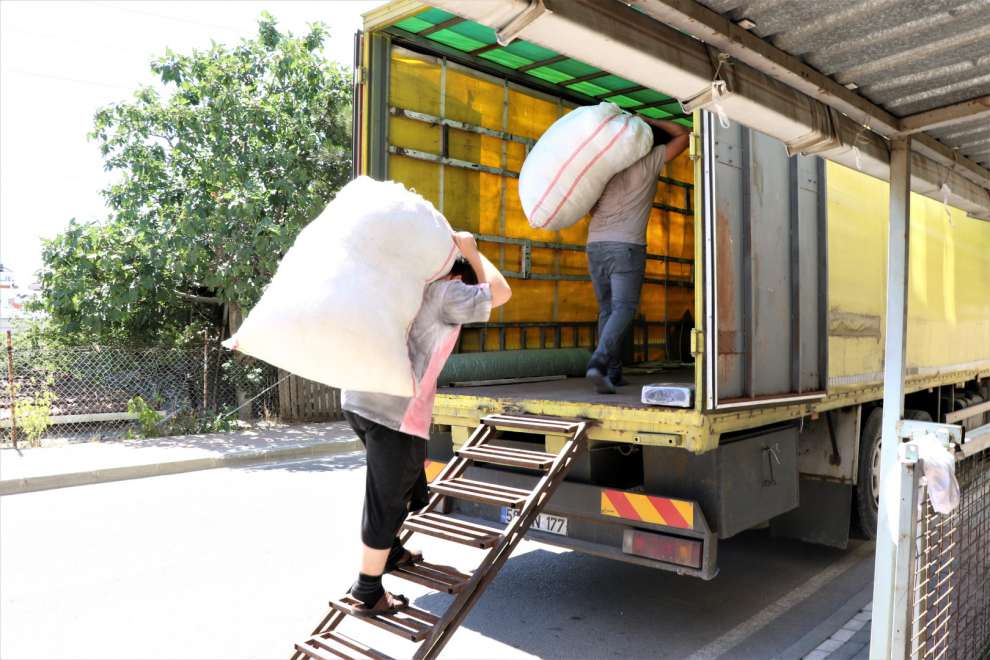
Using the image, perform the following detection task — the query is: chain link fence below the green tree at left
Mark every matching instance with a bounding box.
[0,342,284,445]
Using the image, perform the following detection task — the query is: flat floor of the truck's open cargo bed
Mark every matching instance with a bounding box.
[438,367,694,408]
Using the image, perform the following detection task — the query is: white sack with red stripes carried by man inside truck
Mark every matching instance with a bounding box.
[519,103,653,230]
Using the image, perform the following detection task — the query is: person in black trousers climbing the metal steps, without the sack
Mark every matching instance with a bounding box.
[342,232,512,616]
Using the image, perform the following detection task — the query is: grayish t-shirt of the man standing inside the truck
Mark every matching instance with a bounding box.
[588,145,667,245]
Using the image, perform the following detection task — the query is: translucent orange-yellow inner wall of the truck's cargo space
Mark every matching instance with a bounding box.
[388,47,694,359]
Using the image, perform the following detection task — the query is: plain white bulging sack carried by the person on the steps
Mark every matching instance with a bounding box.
[223,176,458,397]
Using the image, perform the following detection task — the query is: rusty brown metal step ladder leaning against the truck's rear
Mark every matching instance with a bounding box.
[291,415,587,660]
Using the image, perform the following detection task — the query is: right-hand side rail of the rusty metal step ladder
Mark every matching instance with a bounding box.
[413,422,587,660]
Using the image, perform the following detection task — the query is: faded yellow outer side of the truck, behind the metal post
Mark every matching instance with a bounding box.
[828,163,990,390]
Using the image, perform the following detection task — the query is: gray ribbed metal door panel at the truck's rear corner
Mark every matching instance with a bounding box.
[701,112,828,410]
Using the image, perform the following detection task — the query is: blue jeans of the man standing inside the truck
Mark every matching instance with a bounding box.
[588,242,646,380]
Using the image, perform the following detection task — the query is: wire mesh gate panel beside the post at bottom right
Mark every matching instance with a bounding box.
[904,427,990,660]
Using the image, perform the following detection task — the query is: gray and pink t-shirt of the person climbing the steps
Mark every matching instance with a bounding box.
[341,280,492,439]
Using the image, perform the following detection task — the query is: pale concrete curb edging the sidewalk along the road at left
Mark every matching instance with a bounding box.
[0,439,362,497]
